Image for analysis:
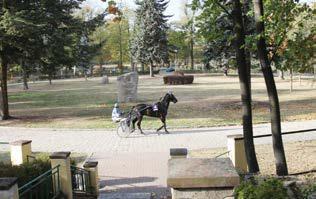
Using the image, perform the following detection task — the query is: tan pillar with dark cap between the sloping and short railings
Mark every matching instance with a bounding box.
[49,152,73,199]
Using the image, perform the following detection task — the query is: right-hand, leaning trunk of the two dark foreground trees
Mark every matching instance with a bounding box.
[253,0,288,176]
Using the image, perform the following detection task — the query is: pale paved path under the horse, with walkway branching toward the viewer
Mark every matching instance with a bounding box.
[0,120,316,197]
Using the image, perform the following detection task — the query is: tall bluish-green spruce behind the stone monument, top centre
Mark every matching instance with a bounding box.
[132,0,169,77]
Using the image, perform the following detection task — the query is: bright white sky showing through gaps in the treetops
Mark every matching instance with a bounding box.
[84,0,316,21]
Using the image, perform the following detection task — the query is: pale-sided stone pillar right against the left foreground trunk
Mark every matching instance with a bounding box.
[227,134,248,173]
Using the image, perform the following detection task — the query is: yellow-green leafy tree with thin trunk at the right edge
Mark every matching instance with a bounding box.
[274,5,316,92]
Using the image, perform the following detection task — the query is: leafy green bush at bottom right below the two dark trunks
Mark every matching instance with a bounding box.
[235,178,287,199]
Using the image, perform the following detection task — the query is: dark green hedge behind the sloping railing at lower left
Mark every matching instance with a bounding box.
[0,159,51,186]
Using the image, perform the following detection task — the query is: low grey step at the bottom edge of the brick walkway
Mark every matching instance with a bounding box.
[98,193,154,199]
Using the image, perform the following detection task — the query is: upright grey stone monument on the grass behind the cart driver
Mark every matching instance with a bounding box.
[117,72,138,103]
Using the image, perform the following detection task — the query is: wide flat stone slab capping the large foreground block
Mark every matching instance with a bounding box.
[167,158,239,189]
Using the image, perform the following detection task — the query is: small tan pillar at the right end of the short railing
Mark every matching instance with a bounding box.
[83,161,100,196]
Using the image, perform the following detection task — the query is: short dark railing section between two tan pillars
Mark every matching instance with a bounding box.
[71,166,93,194]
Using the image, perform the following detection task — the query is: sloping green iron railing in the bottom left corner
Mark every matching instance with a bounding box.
[19,165,61,199]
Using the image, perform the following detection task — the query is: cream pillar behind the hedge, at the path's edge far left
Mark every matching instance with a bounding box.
[10,140,32,165]
